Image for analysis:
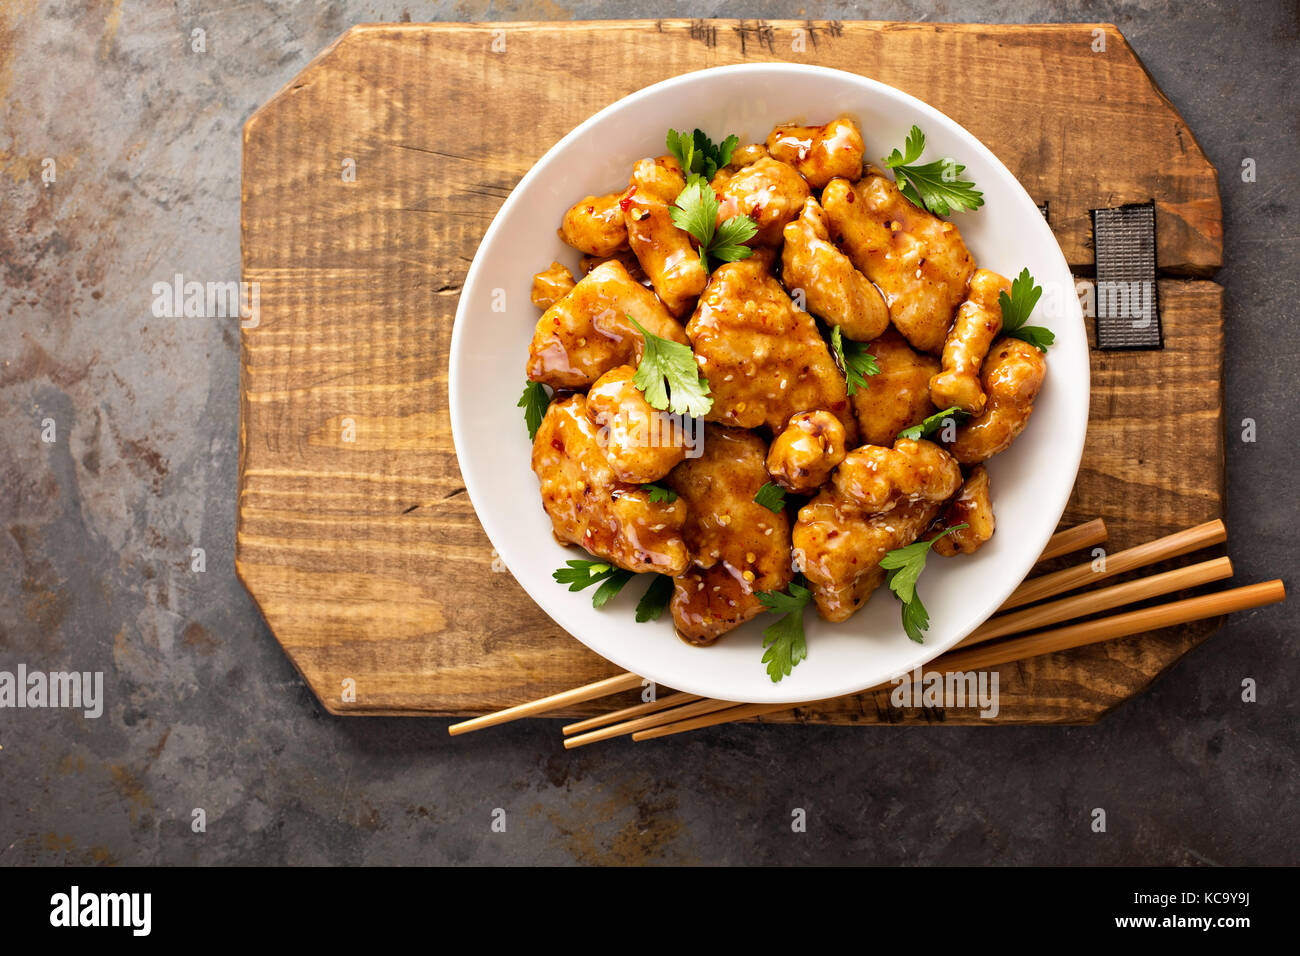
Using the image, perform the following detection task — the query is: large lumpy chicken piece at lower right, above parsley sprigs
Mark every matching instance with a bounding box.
[793,440,962,620]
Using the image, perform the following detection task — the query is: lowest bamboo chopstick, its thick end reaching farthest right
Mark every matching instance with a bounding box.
[632,579,1287,741]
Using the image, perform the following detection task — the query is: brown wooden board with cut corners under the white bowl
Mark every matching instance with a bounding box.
[235,21,1223,723]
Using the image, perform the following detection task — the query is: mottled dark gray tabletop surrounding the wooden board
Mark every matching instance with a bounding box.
[0,0,1300,865]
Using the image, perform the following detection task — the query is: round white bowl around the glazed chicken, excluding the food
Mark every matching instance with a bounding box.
[450,64,1088,704]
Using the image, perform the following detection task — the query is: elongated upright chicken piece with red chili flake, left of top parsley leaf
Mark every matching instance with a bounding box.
[623,156,709,316]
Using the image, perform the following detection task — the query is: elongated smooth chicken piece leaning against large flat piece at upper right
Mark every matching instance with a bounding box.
[781,198,889,342]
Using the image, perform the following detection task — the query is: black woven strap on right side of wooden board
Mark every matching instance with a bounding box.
[1092,202,1165,350]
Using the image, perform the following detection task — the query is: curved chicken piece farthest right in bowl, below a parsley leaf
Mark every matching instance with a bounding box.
[948,338,1048,464]
